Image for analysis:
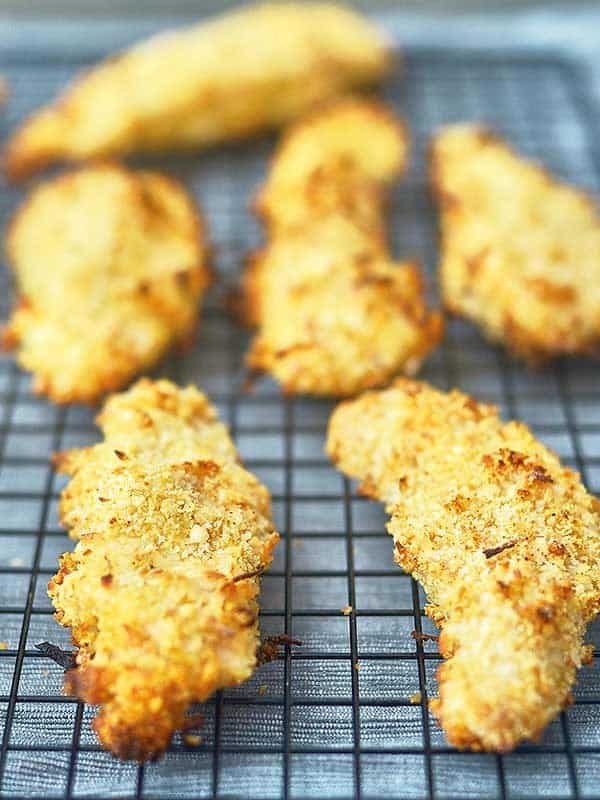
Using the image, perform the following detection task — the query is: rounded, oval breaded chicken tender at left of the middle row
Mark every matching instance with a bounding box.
[3,164,209,403]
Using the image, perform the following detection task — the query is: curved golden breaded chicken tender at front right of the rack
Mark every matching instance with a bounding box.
[327,380,600,752]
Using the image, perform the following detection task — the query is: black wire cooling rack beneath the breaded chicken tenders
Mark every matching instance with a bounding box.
[0,36,600,800]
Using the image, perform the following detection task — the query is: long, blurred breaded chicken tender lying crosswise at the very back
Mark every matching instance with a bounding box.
[6,3,390,179]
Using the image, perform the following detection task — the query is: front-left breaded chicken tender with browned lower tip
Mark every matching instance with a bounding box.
[48,379,279,761]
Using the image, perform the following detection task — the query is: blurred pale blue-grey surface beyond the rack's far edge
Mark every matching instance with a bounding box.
[0,0,600,85]
